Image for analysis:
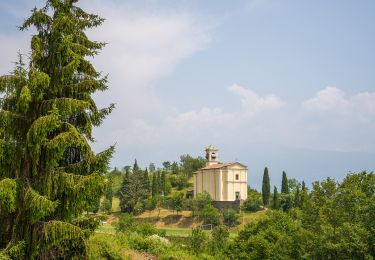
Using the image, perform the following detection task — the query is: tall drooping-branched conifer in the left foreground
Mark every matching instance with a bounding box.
[0,0,114,259]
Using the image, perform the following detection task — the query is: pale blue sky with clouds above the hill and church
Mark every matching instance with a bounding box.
[0,0,375,188]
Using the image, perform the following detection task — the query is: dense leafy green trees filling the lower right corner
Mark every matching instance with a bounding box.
[226,172,375,259]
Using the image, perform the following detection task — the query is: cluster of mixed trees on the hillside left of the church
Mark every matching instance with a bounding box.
[97,154,205,214]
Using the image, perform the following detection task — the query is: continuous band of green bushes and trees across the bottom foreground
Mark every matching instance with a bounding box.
[89,172,375,260]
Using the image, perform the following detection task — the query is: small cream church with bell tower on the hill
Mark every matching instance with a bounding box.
[193,145,247,202]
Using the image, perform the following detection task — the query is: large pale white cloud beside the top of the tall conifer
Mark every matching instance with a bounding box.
[86,1,211,90]
